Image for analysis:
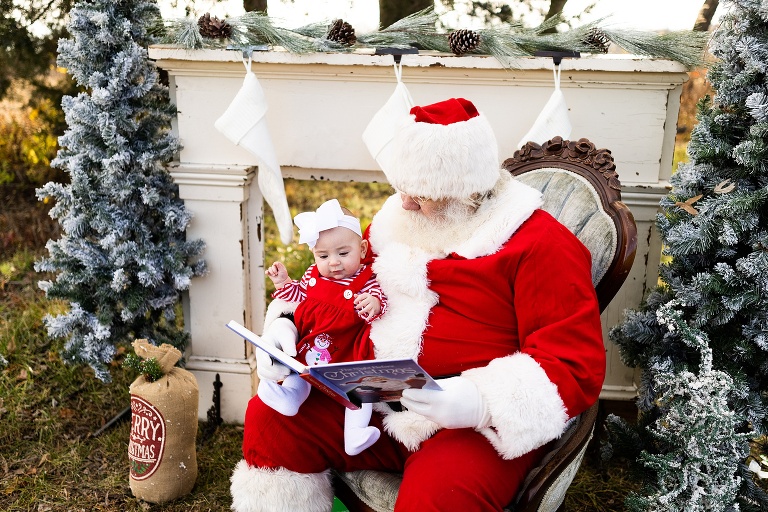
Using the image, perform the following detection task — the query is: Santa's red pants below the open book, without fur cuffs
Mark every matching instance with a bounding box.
[243,389,543,512]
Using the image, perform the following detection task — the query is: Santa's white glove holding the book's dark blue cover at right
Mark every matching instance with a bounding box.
[400,377,491,428]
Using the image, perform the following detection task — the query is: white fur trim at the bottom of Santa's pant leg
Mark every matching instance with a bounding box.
[229,460,333,512]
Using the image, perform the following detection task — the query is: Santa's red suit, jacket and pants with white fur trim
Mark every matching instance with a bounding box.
[232,172,605,511]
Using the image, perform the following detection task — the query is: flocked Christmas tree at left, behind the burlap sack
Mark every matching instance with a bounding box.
[37,0,205,380]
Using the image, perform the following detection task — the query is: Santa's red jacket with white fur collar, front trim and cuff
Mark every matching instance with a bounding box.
[368,173,605,458]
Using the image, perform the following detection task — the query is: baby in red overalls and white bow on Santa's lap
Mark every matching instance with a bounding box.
[258,199,387,455]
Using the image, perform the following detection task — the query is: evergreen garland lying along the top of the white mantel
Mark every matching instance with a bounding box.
[155,7,709,68]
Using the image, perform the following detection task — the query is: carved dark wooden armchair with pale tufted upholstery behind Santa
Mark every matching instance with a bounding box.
[335,137,637,512]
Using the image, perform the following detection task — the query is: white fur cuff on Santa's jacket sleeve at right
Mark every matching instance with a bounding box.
[461,352,568,460]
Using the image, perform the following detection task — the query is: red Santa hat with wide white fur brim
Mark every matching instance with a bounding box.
[382,98,501,199]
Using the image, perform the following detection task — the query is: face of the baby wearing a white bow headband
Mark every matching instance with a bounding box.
[312,227,368,279]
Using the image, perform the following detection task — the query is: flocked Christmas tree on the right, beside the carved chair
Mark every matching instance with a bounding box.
[608,0,768,511]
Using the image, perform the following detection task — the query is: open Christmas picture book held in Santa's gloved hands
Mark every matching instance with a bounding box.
[227,320,441,409]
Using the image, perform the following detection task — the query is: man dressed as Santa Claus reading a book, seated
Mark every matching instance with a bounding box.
[231,99,605,512]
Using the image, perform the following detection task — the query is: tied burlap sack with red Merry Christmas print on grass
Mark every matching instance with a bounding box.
[128,340,198,503]
